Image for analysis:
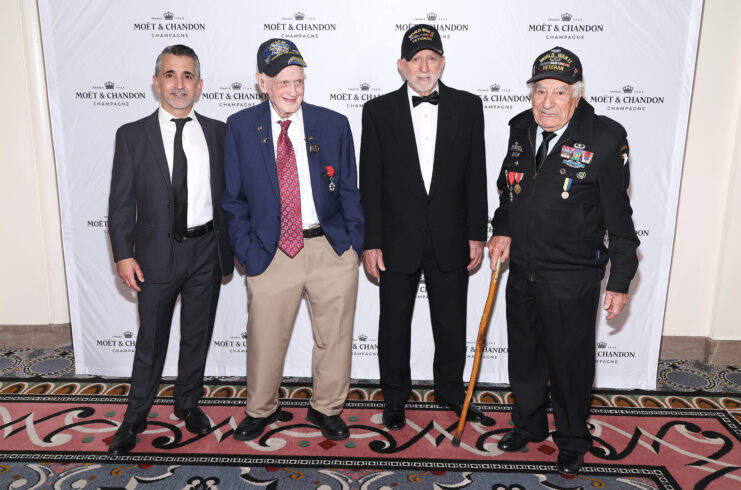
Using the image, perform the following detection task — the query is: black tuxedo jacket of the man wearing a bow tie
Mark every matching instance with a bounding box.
[360,82,488,273]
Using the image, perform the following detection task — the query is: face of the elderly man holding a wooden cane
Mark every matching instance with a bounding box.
[533,78,581,131]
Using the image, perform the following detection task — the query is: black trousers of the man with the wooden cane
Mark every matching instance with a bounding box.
[507,274,600,454]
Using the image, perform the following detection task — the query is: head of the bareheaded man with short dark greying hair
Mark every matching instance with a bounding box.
[152,54,203,117]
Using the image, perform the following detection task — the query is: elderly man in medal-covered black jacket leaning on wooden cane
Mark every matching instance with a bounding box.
[487,47,639,474]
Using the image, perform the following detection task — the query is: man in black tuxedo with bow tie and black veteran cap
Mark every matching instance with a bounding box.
[360,24,487,430]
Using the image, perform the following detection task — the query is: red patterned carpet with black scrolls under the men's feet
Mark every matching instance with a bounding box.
[0,378,741,490]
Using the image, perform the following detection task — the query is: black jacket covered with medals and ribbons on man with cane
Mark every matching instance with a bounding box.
[492,99,640,293]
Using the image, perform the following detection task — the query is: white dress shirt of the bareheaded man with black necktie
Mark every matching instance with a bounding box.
[158,106,214,228]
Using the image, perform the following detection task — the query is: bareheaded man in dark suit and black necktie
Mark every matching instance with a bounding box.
[108,45,234,456]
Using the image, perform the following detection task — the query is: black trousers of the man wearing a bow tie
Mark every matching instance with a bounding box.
[378,233,468,404]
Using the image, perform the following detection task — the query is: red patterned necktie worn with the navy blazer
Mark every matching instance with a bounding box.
[275,121,304,258]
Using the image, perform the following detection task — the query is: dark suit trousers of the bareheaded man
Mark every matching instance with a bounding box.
[124,232,221,423]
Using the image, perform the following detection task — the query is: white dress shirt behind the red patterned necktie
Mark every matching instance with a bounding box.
[270,104,319,230]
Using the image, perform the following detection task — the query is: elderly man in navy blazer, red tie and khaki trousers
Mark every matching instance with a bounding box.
[223,39,363,441]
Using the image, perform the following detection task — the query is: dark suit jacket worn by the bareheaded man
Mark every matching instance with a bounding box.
[108,111,234,283]
